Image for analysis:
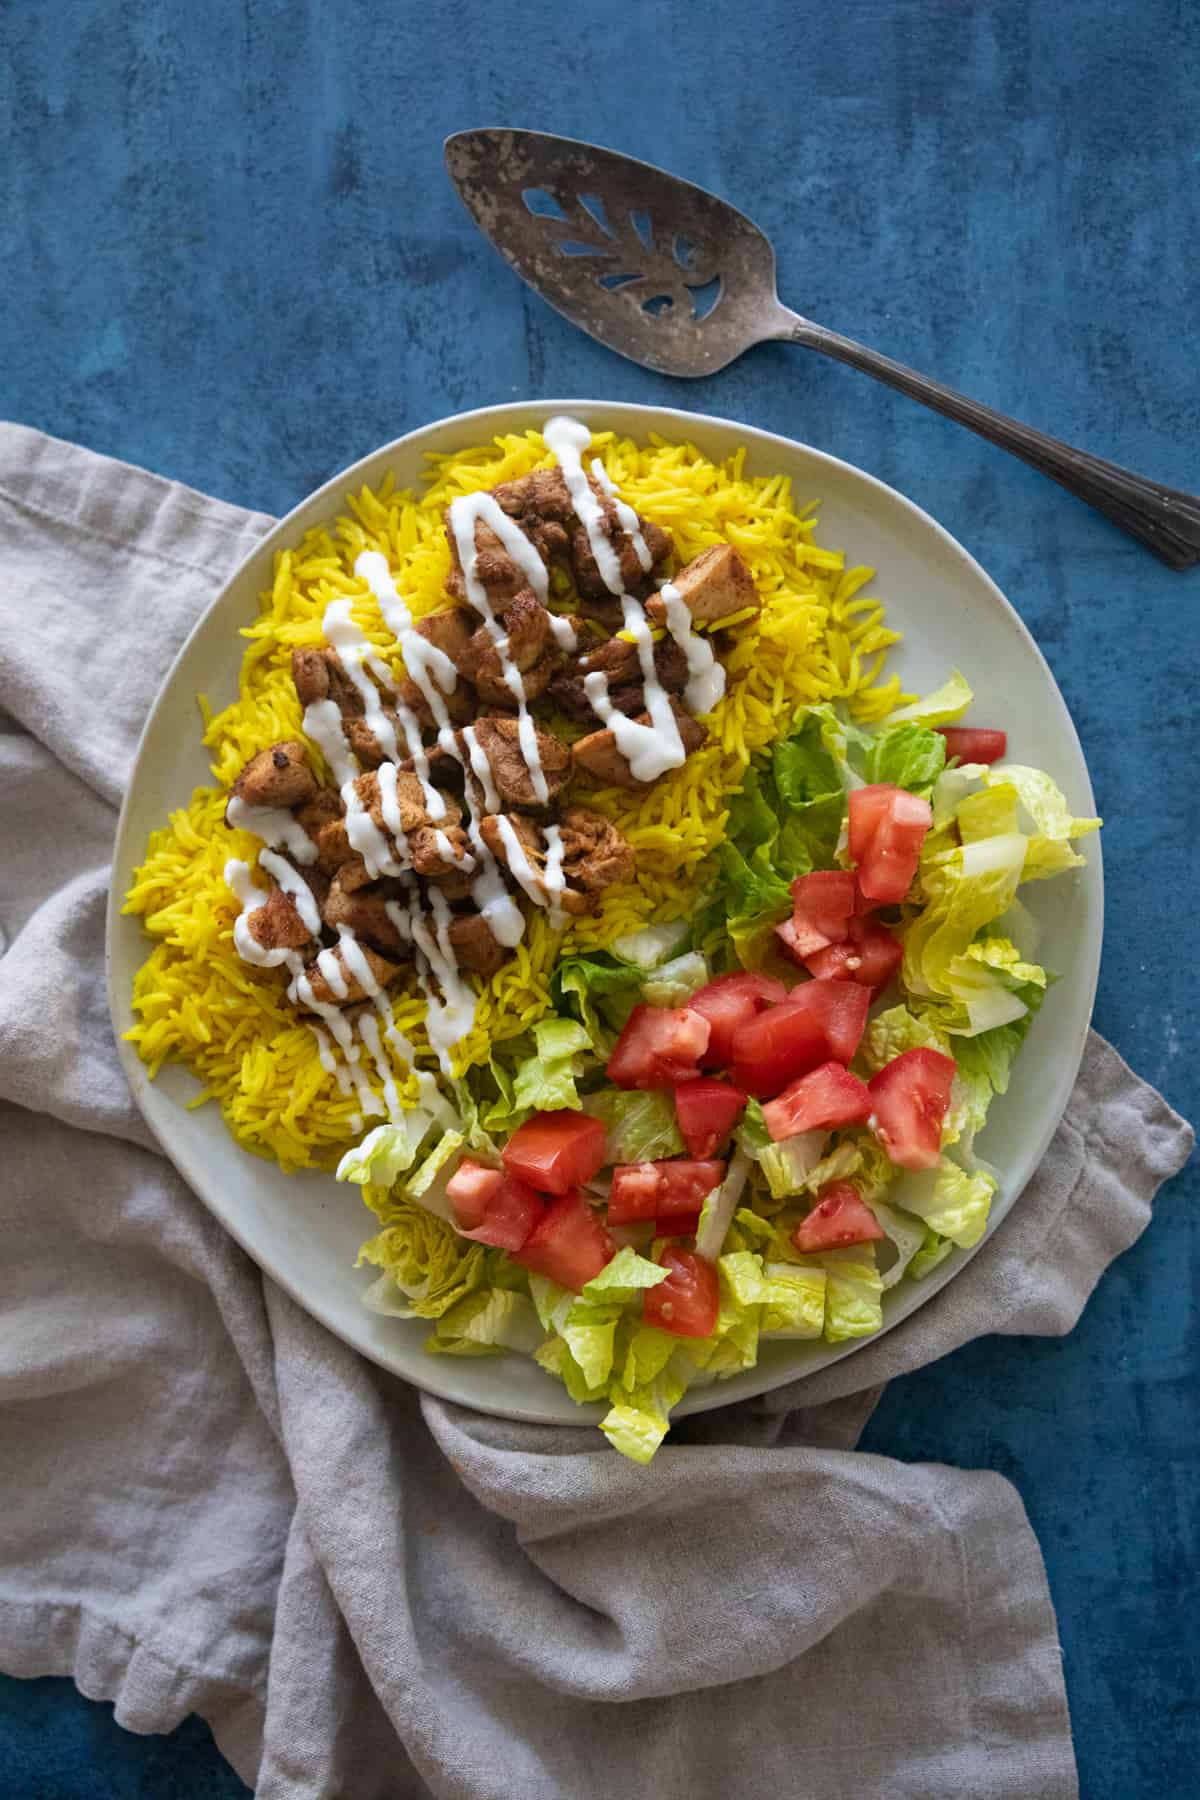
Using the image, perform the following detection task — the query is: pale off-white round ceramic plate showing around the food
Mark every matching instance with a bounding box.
[108,400,1103,1424]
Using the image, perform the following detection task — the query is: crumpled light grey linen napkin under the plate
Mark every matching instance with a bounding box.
[0,427,1191,1800]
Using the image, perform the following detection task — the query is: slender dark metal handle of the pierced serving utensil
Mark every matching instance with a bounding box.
[786,319,1200,569]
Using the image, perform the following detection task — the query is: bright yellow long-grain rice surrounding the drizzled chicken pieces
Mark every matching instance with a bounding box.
[126,432,901,1168]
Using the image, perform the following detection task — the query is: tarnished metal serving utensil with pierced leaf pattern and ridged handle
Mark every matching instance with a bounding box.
[446,131,1200,569]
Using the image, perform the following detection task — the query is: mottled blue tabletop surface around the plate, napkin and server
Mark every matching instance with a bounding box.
[0,0,1200,1800]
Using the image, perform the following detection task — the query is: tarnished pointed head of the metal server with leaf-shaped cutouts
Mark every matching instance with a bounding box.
[446,130,786,374]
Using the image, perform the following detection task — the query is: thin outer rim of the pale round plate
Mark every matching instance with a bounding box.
[104,396,1105,1426]
